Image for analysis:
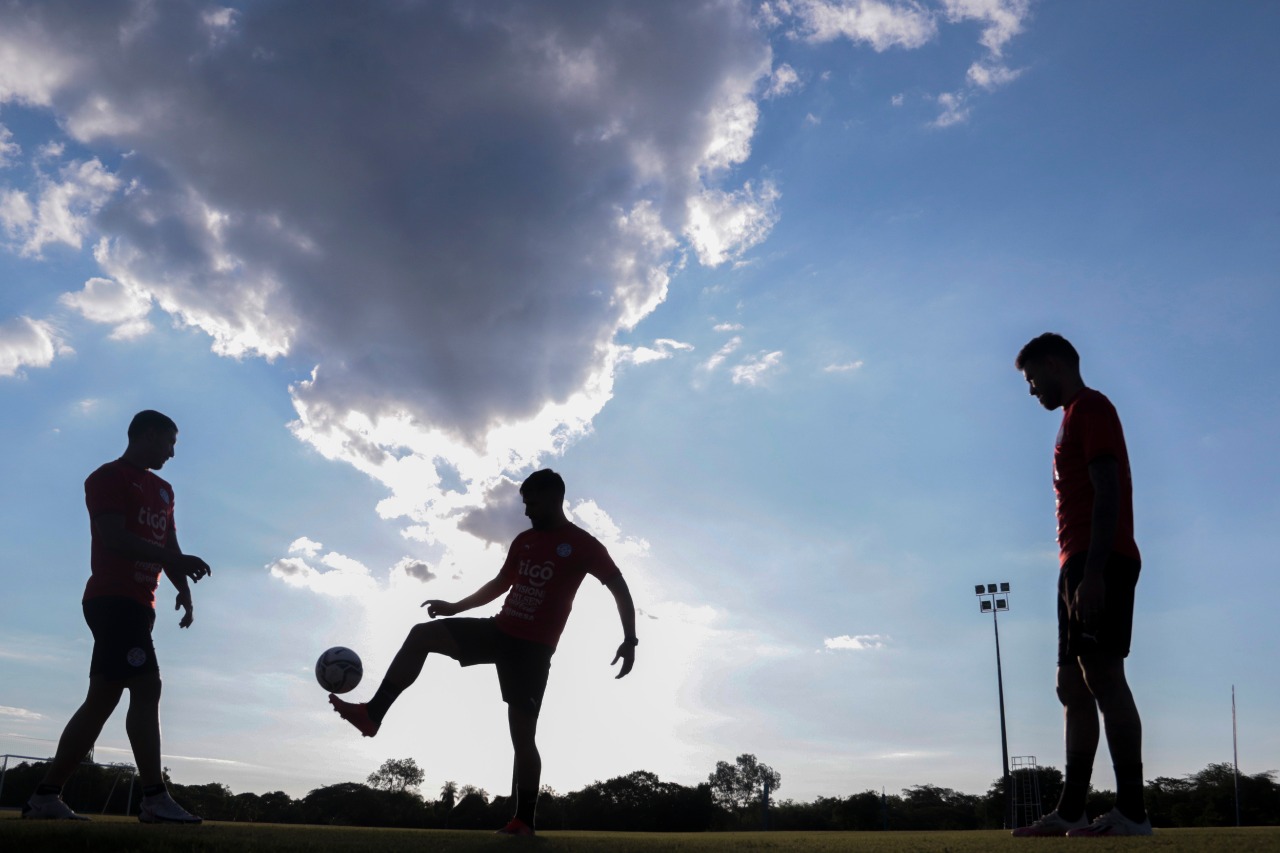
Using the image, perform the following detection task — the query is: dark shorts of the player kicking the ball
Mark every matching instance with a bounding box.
[440,617,556,717]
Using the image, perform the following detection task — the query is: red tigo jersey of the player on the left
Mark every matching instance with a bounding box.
[84,459,174,607]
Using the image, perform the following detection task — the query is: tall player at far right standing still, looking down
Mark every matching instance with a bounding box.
[1014,332,1151,836]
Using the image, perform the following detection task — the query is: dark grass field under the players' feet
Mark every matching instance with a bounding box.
[0,813,1280,853]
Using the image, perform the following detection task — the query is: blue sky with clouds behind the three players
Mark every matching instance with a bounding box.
[0,0,1280,800]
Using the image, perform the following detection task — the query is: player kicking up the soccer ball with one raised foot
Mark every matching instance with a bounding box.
[329,469,639,835]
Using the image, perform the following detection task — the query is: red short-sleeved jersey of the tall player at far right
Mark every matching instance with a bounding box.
[1053,388,1140,564]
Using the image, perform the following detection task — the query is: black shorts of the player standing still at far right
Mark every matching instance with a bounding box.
[1057,552,1142,666]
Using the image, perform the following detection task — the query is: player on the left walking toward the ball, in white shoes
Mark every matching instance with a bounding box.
[22,410,210,824]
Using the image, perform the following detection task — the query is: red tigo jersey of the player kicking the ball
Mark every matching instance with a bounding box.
[497,524,622,648]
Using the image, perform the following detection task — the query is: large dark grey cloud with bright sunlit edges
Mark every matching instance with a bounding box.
[0,0,778,537]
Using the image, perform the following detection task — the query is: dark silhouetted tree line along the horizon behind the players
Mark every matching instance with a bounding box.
[0,753,1280,831]
